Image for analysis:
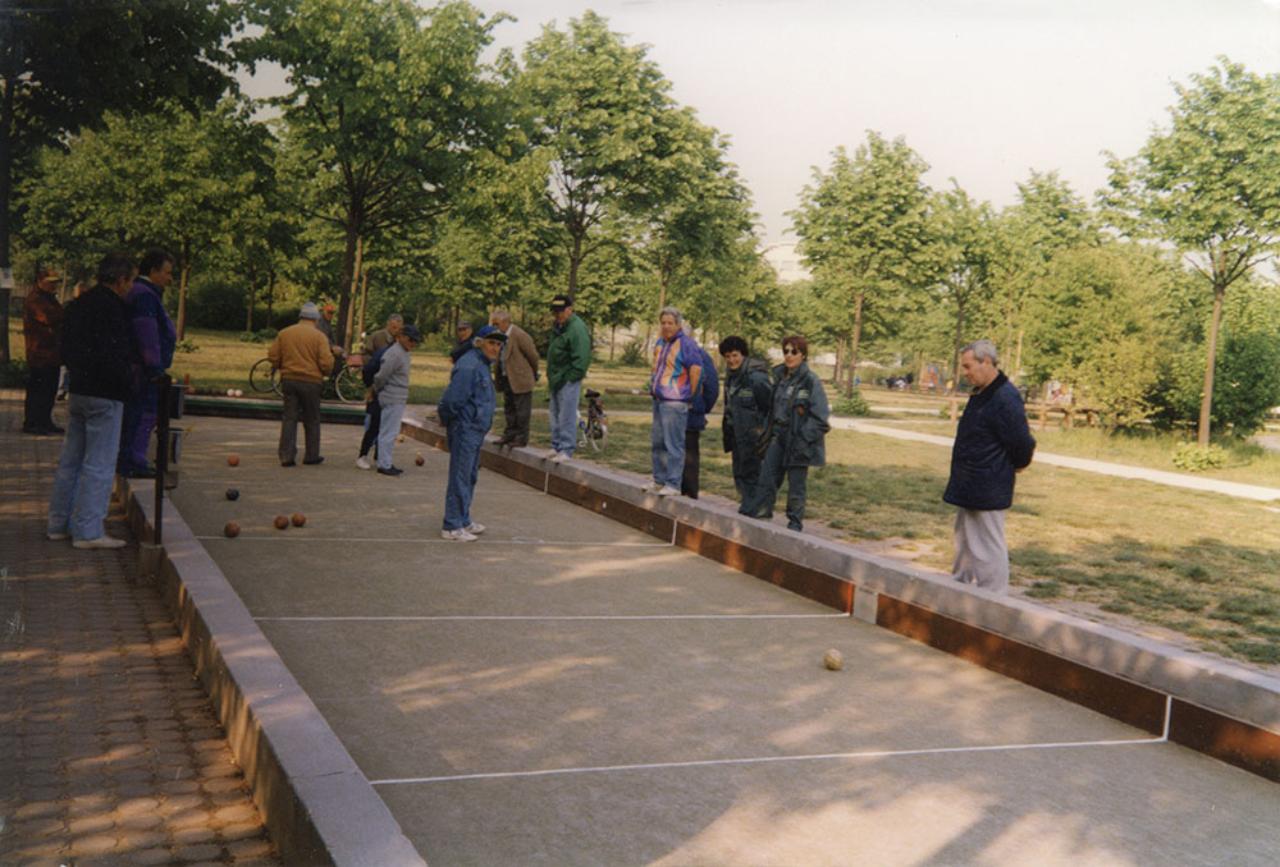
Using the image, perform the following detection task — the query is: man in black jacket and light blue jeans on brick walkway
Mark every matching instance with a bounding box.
[46,255,137,548]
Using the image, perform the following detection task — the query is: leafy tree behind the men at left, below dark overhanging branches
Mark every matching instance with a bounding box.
[24,100,270,339]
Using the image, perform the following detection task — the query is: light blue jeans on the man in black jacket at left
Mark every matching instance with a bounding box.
[47,394,124,540]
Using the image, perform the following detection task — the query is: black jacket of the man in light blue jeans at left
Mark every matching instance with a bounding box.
[61,283,142,402]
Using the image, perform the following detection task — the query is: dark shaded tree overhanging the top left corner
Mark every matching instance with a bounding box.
[0,0,239,364]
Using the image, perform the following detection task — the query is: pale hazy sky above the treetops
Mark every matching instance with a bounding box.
[241,0,1280,245]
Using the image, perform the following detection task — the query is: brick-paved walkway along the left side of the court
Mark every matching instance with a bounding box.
[0,401,280,867]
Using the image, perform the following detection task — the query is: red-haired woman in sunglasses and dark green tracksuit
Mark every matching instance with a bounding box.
[737,334,831,531]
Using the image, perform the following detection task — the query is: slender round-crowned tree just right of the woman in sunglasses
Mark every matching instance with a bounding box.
[791,131,929,392]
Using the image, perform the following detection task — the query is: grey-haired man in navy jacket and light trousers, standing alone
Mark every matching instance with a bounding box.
[942,341,1036,592]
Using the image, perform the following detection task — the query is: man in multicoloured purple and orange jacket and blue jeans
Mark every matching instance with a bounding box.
[648,307,703,497]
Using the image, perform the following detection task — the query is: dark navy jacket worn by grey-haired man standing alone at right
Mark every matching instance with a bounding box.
[942,373,1036,510]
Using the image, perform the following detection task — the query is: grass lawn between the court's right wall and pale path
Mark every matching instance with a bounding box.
[565,416,1280,666]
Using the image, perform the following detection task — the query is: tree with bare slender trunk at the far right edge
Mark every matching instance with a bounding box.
[1102,58,1280,446]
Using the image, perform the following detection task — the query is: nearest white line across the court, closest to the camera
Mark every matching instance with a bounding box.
[370,738,1167,786]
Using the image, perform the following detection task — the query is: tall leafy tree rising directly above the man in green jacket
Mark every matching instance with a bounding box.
[517,12,705,295]
